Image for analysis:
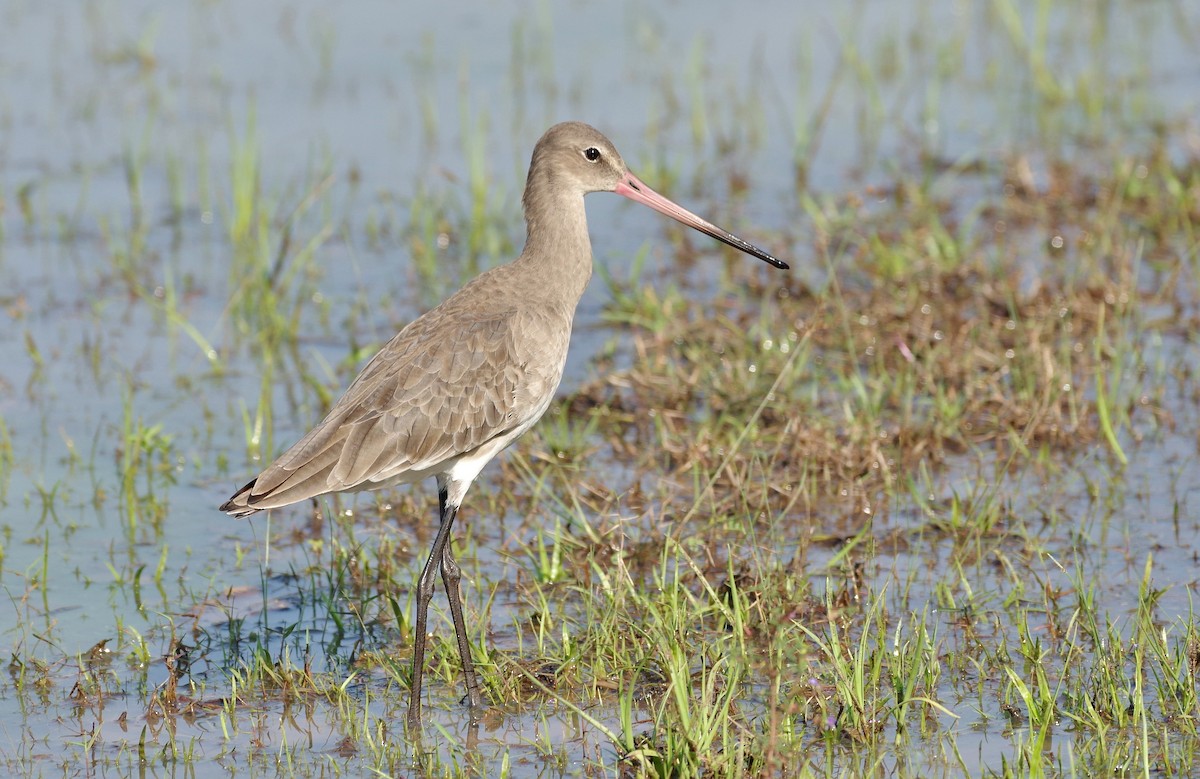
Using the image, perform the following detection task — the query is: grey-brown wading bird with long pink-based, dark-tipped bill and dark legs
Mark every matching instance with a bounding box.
[221,122,787,726]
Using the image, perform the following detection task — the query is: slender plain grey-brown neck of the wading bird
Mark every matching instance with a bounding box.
[518,188,592,310]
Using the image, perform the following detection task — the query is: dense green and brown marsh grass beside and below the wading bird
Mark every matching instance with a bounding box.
[10,147,1200,777]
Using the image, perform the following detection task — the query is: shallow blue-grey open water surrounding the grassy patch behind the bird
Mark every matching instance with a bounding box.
[0,0,1200,775]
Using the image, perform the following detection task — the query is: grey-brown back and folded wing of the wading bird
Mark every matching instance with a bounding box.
[221,263,577,516]
